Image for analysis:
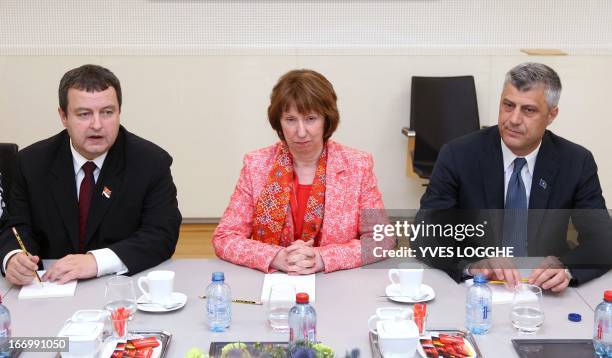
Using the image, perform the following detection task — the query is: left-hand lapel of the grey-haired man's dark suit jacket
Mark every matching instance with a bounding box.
[480,126,504,242]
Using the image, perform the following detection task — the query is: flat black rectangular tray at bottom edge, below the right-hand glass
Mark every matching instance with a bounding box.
[512,339,595,358]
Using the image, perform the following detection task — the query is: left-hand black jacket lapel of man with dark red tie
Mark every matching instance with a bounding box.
[51,133,79,252]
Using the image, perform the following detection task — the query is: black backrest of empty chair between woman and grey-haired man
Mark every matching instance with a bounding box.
[410,76,480,178]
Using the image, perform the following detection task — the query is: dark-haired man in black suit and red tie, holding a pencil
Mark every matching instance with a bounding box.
[0,65,181,285]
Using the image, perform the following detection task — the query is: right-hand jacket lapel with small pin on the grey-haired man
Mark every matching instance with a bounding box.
[528,131,559,247]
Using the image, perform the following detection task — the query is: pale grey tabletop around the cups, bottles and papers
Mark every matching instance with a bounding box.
[5,259,612,357]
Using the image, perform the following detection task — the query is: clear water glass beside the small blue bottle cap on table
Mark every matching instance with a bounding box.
[510,283,544,334]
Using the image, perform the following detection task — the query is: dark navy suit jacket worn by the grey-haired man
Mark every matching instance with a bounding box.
[419,126,612,284]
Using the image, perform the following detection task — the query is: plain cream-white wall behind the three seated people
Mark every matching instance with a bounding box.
[0,53,612,217]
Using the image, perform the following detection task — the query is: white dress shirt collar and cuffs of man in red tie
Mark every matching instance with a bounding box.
[2,141,128,277]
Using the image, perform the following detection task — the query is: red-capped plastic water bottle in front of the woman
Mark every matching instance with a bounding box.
[289,292,317,343]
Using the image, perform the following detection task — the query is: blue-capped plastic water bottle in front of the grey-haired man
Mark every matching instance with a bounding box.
[465,275,493,334]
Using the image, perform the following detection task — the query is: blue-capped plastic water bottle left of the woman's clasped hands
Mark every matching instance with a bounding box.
[206,272,232,332]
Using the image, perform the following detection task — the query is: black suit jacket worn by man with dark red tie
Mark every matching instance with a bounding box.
[0,127,181,274]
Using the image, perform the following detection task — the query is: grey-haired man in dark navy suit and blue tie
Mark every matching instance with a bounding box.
[417,63,612,292]
